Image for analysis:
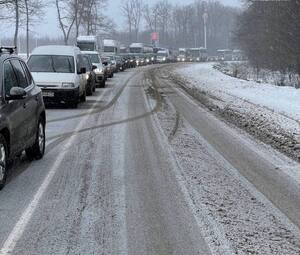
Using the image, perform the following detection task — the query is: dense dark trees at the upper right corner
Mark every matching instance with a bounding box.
[236,0,300,75]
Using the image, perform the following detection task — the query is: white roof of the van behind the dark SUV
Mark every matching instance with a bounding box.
[31,45,80,56]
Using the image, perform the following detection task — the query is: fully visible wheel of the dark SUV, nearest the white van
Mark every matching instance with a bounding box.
[25,118,46,160]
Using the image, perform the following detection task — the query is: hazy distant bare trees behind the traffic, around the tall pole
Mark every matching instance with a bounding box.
[119,0,240,51]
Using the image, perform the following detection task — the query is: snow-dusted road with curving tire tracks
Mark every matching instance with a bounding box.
[0,65,300,255]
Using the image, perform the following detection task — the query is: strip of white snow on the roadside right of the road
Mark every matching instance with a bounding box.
[176,63,300,121]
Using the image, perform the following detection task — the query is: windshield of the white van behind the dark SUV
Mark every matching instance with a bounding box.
[28,55,75,73]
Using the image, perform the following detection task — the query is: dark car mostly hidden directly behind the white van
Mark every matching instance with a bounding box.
[80,54,97,96]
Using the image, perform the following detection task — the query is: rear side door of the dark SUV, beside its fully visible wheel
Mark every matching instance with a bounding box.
[11,59,38,148]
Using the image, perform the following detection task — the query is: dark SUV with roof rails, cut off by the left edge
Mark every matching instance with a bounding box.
[0,47,46,190]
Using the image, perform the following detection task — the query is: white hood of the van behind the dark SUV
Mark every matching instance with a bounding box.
[32,72,77,86]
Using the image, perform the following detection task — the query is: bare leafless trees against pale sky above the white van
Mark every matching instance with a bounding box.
[0,0,114,54]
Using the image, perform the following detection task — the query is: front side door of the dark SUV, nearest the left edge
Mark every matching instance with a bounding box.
[3,60,27,156]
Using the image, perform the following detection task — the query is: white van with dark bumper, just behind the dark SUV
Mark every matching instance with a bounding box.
[28,46,87,108]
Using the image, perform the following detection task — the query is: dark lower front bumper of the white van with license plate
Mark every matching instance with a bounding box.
[41,88,79,103]
